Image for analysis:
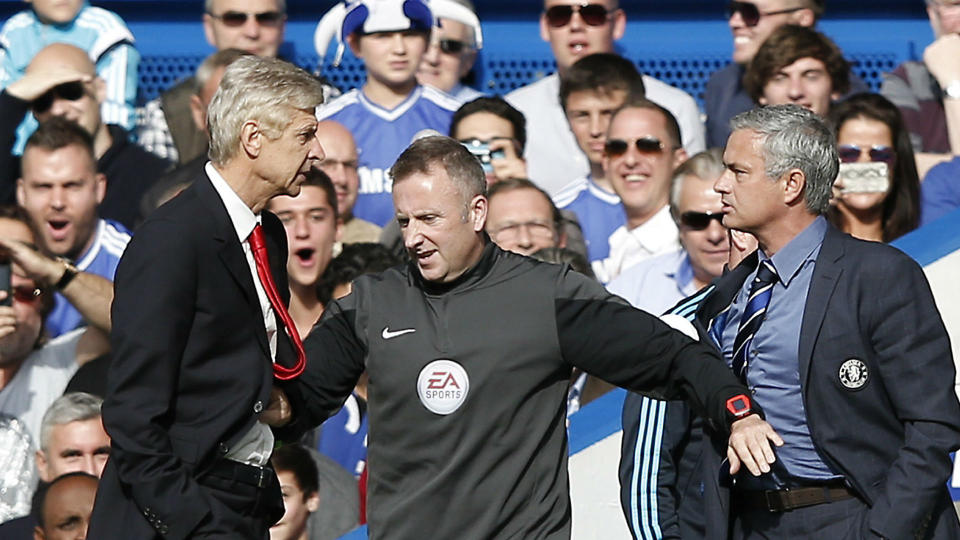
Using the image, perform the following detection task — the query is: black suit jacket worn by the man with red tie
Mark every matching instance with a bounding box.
[89,175,292,539]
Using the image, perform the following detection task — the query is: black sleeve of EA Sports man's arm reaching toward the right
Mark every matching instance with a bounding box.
[555,268,748,432]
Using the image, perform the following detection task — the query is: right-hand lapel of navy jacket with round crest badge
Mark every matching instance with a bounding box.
[797,226,843,387]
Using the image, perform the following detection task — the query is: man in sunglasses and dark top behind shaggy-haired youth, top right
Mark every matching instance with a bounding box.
[704,0,869,148]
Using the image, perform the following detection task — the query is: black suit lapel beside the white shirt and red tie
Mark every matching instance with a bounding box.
[194,173,270,358]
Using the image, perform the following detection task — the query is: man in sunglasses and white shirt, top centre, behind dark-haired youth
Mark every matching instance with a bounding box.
[506,0,706,196]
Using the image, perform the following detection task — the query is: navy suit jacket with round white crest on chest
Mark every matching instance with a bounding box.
[695,227,960,539]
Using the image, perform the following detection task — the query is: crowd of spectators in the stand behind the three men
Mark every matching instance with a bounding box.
[0,0,960,540]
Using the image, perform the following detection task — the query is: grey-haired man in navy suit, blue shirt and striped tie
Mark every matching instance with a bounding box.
[695,105,960,538]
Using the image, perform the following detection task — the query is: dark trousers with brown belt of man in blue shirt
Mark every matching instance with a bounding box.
[733,498,878,540]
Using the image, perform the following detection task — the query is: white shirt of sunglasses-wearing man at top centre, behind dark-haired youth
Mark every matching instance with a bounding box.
[505,73,707,197]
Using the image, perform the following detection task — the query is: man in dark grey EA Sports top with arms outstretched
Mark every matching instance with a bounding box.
[276,137,779,540]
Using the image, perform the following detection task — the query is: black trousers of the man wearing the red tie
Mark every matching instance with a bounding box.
[191,466,283,540]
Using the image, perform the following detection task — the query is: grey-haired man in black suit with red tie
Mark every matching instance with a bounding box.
[89,56,323,540]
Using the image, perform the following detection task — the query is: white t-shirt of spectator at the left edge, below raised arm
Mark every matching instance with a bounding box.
[0,328,86,450]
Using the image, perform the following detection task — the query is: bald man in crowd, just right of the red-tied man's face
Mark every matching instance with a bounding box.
[317,120,380,244]
